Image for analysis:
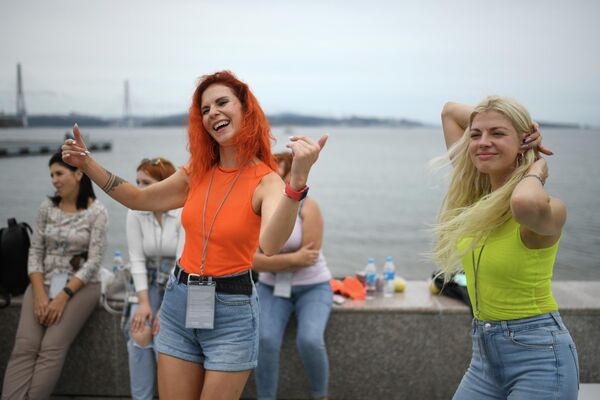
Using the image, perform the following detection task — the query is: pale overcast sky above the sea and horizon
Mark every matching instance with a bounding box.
[0,0,600,126]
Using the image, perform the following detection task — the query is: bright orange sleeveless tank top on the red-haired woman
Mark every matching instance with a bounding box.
[179,162,273,276]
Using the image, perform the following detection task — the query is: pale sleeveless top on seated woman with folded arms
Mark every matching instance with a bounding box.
[258,209,331,286]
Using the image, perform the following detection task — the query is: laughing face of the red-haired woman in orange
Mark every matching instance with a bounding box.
[200,83,243,146]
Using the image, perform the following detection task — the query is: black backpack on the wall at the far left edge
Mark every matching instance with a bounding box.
[0,218,33,308]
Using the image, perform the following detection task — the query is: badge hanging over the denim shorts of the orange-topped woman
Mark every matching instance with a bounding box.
[185,275,217,329]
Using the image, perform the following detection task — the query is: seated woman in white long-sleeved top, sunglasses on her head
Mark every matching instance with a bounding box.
[125,157,185,400]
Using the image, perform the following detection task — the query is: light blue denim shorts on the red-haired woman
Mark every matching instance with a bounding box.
[156,272,258,372]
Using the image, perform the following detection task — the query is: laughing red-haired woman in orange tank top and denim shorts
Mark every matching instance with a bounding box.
[62,71,327,400]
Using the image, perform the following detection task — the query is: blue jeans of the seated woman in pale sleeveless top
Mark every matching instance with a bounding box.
[255,282,333,399]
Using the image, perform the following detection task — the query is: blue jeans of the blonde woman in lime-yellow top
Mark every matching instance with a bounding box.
[454,312,579,400]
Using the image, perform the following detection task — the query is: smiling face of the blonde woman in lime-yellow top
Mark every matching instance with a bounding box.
[469,110,521,178]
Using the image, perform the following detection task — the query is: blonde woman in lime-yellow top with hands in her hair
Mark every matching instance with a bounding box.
[434,97,578,400]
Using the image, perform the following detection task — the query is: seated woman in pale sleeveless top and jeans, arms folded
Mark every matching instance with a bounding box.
[252,153,333,399]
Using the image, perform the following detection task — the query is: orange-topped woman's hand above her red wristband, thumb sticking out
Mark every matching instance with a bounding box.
[286,135,329,190]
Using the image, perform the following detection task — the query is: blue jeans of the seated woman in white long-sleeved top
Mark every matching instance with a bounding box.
[124,271,163,400]
